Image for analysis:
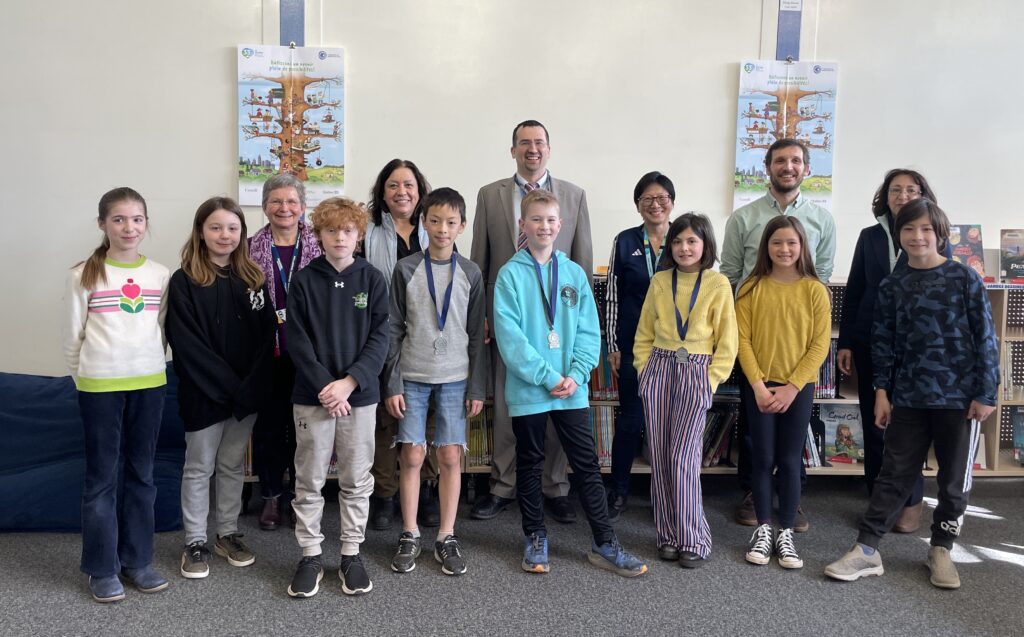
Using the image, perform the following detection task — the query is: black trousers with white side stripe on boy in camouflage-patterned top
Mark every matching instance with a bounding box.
[857,407,981,549]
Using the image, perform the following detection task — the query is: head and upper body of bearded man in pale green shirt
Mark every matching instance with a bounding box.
[719,139,836,289]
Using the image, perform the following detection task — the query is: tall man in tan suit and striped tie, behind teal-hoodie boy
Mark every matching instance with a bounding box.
[470,120,594,522]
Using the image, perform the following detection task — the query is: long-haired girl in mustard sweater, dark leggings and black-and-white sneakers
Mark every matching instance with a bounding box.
[736,216,831,568]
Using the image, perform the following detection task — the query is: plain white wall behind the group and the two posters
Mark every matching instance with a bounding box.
[0,0,1024,374]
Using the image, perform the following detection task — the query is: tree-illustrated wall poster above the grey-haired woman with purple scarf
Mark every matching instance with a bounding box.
[238,44,345,206]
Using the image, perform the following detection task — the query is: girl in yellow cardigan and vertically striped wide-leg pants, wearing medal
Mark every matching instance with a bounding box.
[633,213,736,568]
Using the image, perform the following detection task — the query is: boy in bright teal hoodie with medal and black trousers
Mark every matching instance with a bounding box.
[494,189,647,577]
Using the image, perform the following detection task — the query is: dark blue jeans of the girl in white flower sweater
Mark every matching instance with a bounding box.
[78,387,166,578]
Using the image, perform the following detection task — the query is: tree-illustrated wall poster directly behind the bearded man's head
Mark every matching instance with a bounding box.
[732,59,839,211]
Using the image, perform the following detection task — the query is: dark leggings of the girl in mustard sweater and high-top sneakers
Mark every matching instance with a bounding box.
[740,379,814,528]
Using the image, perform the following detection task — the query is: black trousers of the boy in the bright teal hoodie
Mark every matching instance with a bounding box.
[512,408,615,545]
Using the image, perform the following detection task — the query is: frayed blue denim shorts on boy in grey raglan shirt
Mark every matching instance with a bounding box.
[394,380,466,448]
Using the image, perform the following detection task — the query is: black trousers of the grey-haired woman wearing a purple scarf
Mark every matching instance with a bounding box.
[253,352,295,498]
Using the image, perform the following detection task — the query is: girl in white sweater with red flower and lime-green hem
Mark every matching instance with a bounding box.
[63,187,169,602]
